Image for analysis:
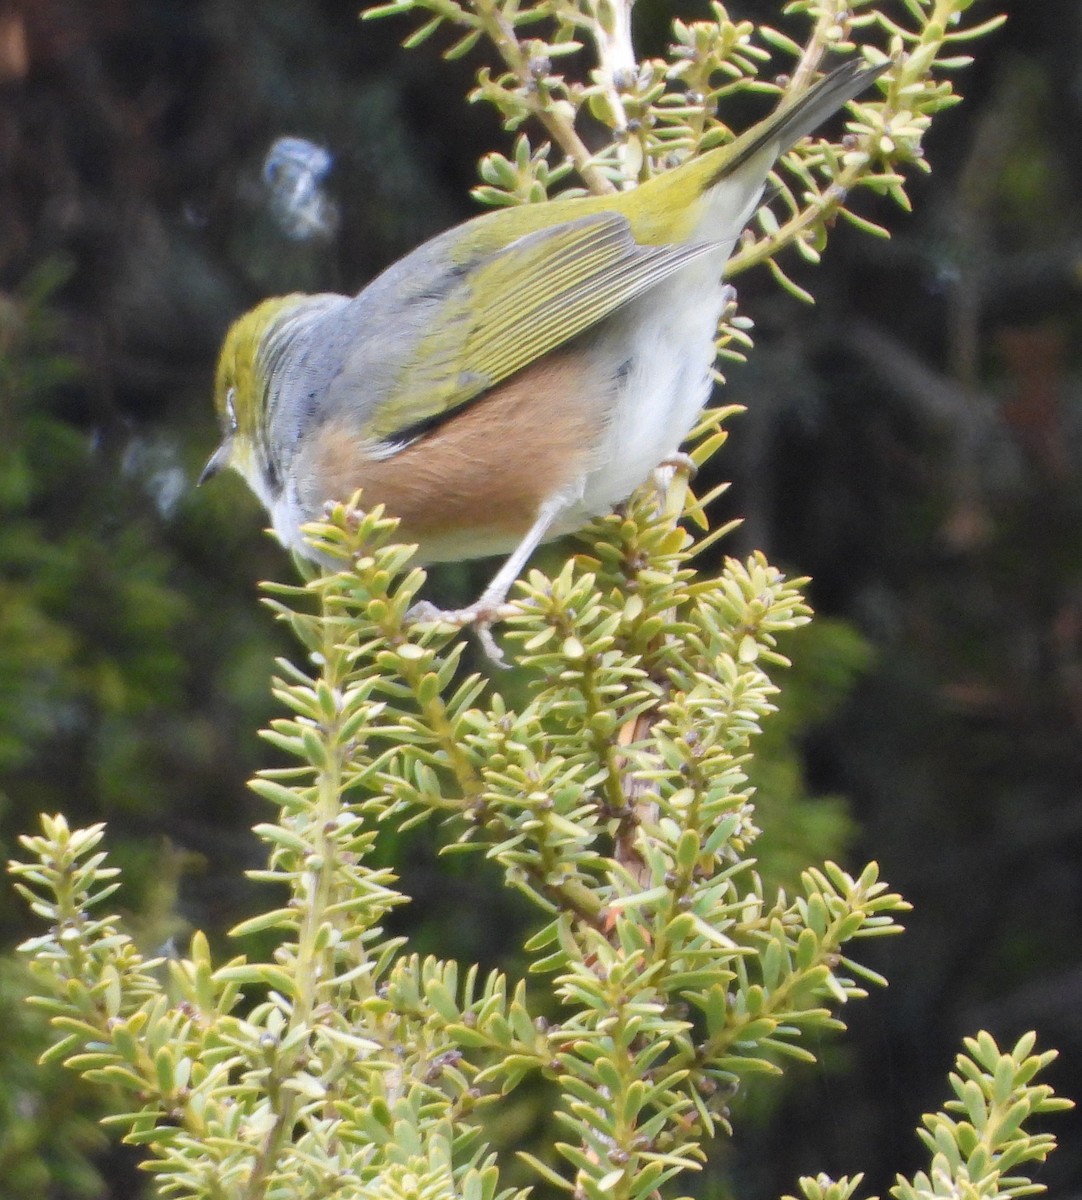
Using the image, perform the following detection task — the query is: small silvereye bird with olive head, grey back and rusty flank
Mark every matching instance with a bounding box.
[200,61,883,624]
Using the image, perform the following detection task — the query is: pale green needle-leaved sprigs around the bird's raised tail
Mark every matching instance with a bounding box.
[363,0,1005,299]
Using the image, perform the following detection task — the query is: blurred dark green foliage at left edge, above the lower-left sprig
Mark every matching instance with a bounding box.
[0,256,284,844]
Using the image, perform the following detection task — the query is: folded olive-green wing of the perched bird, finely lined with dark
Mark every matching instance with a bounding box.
[352,212,717,445]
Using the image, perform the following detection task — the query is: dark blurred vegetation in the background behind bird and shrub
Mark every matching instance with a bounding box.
[0,0,1082,1200]
